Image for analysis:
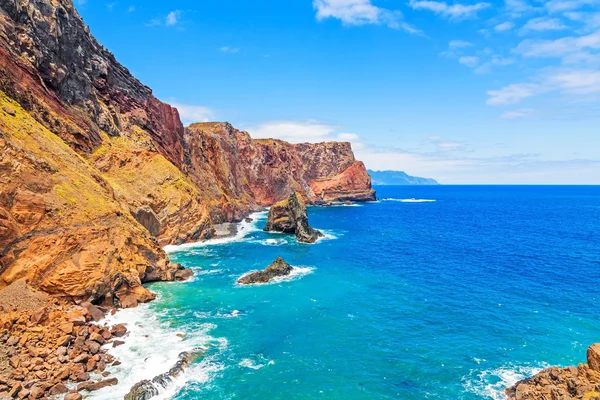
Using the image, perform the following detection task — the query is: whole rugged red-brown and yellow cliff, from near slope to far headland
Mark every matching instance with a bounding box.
[0,0,374,306]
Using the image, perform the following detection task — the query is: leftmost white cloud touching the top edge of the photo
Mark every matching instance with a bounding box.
[313,0,423,35]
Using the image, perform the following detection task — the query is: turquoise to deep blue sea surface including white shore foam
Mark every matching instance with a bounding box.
[94,186,600,400]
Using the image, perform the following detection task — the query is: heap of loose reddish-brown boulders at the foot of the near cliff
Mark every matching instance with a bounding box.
[0,281,127,400]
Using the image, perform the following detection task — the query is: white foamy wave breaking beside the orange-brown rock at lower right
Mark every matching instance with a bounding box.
[463,365,546,400]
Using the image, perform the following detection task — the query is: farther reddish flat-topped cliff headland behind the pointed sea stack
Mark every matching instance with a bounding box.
[186,122,375,208]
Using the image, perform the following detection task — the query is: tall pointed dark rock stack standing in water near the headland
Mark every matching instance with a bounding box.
[264,193,323,243]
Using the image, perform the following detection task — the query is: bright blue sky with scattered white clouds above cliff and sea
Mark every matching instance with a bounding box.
[75,0,600,184]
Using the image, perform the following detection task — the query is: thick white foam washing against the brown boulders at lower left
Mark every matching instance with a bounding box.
[86,304,227,400]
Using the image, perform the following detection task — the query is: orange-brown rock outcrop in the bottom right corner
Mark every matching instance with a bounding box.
[506,343,600,400]
